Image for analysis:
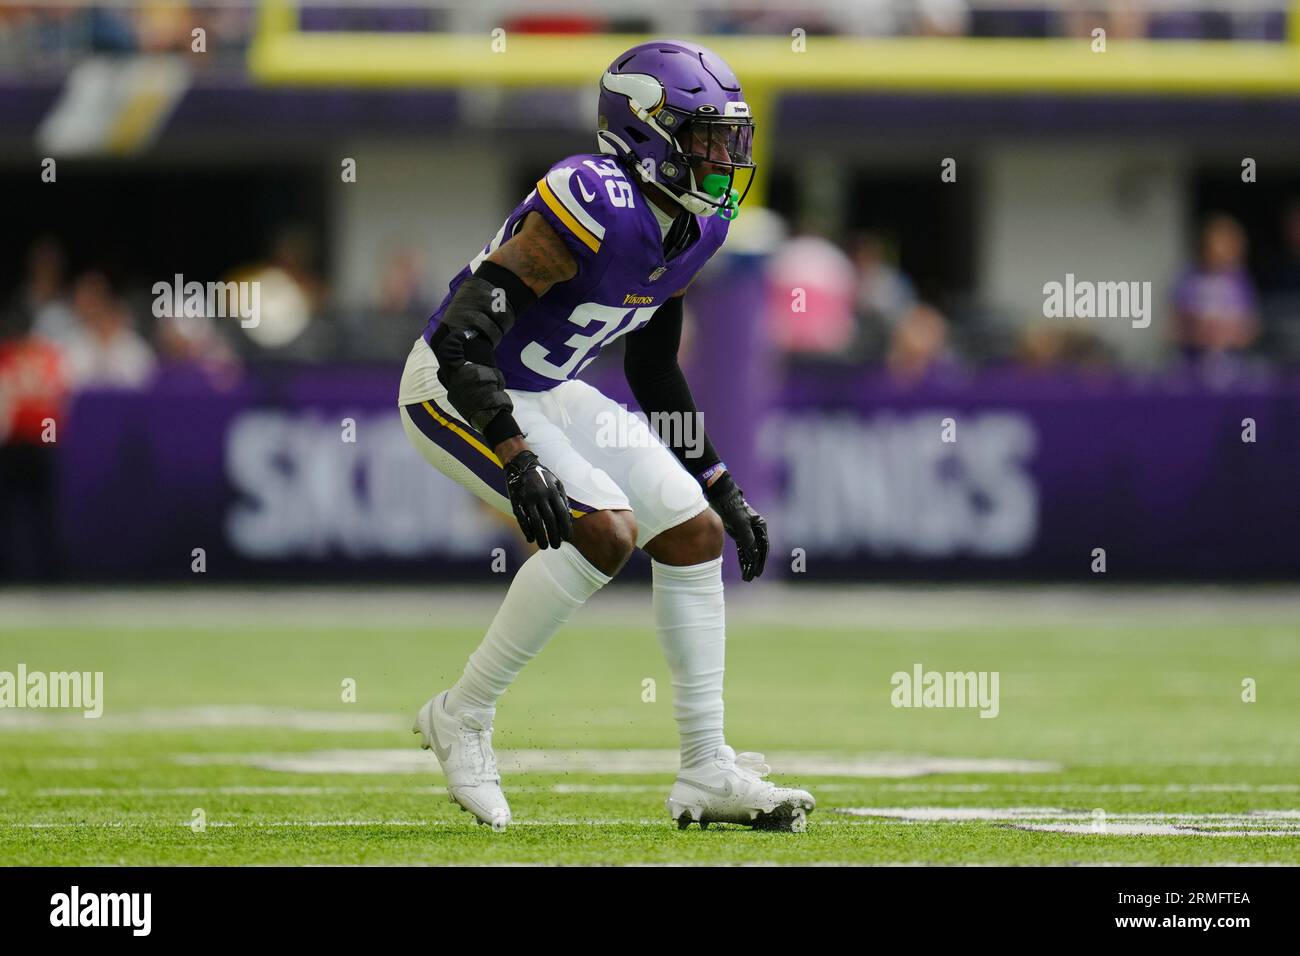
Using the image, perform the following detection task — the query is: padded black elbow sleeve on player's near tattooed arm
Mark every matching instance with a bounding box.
[429,261,537,447]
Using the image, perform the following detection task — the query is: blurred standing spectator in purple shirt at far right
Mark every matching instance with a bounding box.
[1173,213,1260,356]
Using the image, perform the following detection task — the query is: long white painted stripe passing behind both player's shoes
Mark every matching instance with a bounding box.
[174,748,1061,777]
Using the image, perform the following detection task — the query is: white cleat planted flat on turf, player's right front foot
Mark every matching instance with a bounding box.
[667,745,816,832]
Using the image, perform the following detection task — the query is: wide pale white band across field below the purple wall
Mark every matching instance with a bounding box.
[10,581,1300,633]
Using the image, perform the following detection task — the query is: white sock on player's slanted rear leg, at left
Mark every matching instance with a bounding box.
[447,541,610,714]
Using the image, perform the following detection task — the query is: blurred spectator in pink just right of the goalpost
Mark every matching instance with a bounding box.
[767,235,854,359]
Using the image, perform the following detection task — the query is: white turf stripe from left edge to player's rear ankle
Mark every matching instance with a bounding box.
[0,704,408,732]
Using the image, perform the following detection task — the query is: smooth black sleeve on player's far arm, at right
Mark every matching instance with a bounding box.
[623,295,722,479]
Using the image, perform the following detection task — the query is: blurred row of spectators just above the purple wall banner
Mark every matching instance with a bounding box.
[0,199,1300,390]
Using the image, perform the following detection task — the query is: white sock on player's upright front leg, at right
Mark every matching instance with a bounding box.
[650,557,727,767]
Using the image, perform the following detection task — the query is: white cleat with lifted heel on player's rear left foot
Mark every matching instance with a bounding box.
[411,691,510,832]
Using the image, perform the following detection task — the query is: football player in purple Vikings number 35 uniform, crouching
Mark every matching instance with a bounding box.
[398,40,814,830]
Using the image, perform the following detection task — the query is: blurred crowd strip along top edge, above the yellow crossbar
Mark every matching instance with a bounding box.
[0,0,1287,64]
